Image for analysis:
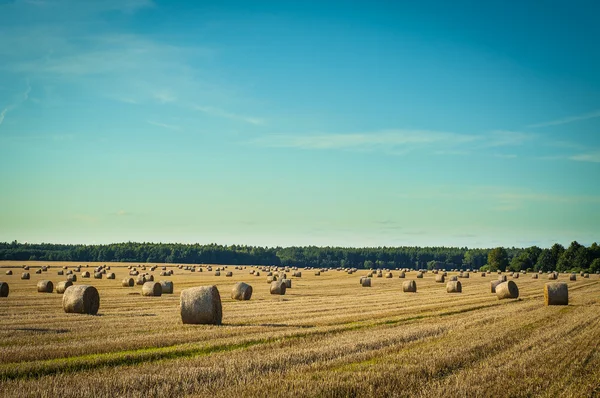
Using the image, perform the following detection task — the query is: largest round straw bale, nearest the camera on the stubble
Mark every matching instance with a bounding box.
[179,286,223,325]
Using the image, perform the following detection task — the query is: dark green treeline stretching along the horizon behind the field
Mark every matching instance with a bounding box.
[0,241,600,273]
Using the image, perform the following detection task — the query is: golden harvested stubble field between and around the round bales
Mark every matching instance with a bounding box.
[0,262,600,398]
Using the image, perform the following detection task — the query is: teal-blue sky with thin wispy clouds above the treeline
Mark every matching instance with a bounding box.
[0,0,600,247]
